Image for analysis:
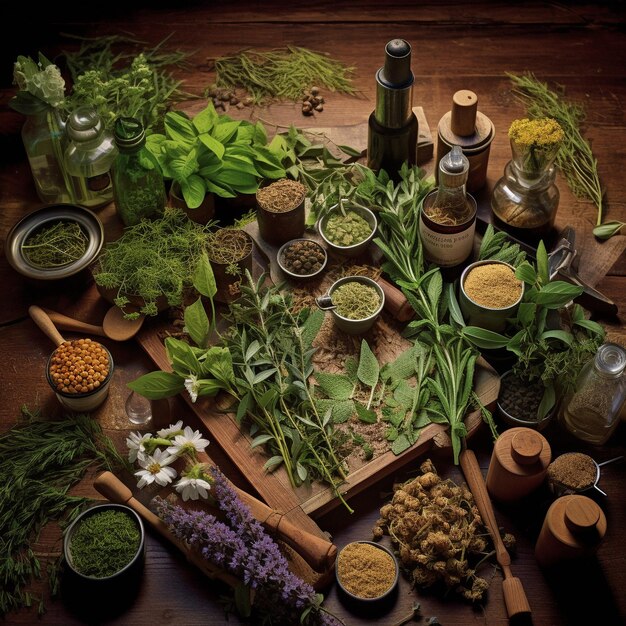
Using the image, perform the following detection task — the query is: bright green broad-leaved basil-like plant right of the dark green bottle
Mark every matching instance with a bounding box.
[146,102,285,209]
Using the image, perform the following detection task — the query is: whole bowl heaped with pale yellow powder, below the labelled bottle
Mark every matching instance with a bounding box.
[459,260,524,332]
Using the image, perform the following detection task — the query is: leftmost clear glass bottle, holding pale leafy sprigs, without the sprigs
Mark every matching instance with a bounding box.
[22,103,73,204]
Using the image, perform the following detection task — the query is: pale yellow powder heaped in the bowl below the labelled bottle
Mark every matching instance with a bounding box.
[463,263,522,309]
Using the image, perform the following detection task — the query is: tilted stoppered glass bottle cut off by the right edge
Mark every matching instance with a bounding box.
[562,343,626,445]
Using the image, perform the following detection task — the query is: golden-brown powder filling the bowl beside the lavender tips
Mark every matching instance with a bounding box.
[337,543,396,598]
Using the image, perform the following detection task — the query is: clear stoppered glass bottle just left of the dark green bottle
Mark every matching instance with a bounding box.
[64,106,117,208]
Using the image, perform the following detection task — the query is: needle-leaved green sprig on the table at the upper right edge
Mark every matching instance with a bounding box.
[507,73,604,226]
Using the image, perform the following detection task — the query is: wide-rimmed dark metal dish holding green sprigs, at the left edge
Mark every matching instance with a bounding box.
[4,204,104,281]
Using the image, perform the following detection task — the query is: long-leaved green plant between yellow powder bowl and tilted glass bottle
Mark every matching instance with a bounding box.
[456,242,604,419]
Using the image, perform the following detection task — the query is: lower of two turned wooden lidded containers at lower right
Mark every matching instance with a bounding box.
[535,495,606,567]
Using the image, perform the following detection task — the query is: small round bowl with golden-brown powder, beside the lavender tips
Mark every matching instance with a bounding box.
[335,541,400,604]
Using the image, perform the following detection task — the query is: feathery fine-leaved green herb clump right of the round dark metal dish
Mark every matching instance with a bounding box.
[93,208,212,318]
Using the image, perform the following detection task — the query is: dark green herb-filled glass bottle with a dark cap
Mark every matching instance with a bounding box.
[111,117,165,226]
